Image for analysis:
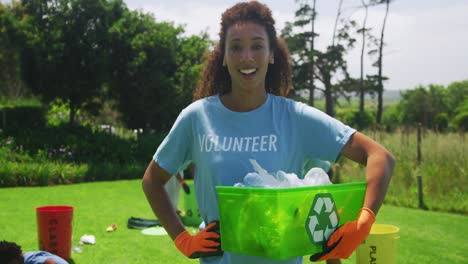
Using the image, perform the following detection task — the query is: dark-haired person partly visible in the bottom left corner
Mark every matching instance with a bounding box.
[0,240,68,264]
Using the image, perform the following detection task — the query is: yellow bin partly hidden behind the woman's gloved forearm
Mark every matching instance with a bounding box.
[356,224,400,264]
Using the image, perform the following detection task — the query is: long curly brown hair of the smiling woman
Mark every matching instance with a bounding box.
[194,1,292,100]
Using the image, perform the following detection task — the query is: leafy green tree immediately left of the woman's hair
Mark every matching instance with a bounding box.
[109,11,209,131]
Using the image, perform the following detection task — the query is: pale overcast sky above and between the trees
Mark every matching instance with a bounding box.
[125,0,468,90]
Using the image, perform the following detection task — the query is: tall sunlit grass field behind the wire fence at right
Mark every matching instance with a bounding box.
[339,131,468,215]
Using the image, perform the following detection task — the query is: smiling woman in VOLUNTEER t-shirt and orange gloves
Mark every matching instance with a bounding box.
[143,1,394,264]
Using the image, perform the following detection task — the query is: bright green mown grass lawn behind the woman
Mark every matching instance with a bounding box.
[0,180,468,264]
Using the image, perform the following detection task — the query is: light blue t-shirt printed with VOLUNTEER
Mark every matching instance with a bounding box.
[153,94,355,264]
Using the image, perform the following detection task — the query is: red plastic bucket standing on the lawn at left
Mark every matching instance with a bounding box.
[36,206,73,260]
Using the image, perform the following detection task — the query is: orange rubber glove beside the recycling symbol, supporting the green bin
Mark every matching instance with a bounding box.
[310,207,375,261]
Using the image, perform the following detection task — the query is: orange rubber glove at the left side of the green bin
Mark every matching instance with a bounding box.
[174,221,223,258]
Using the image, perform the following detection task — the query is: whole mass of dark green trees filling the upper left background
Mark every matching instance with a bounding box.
[5,0,210,130]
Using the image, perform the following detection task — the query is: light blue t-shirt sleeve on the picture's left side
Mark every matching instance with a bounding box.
[153,109,193,175]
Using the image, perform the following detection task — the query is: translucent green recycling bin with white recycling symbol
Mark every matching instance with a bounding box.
[216,182,366,260]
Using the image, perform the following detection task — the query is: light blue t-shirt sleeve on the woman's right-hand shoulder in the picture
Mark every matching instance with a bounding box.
[296,103,356,162]
